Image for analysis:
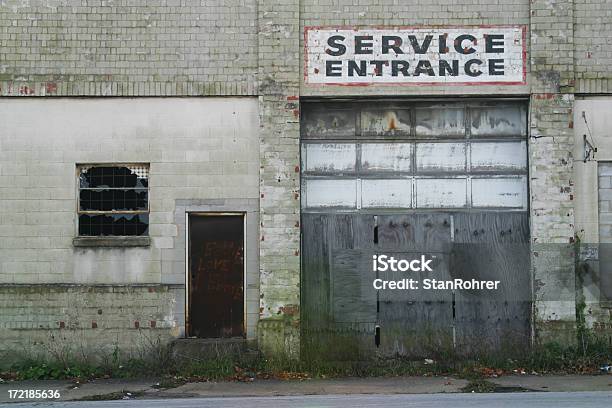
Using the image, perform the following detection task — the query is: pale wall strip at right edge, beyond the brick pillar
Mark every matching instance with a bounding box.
[574,96,612,340]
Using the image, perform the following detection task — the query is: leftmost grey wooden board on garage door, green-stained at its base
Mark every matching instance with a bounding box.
[300,213,376,361]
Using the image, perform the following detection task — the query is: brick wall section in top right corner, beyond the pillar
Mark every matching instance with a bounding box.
[574,0,612,93]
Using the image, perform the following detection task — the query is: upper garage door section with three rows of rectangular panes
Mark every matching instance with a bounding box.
[302,102,527,211]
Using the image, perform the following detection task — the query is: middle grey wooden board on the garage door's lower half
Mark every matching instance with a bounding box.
[378,214,453,357]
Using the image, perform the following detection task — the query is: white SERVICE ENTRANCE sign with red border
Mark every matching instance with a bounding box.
[304,26,526,85]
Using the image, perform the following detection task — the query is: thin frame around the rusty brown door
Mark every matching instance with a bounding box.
[185,211,247,339]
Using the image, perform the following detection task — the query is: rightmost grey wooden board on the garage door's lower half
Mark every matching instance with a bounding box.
[451,213,531,354]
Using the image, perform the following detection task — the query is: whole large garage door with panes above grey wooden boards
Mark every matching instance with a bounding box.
[301,101,531,358]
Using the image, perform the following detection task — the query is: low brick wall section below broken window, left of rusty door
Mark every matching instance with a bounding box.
[0,285,183,367]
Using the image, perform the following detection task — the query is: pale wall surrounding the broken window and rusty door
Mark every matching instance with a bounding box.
[0,97,259,364]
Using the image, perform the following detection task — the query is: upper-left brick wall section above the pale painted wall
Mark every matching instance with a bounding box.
[0,0,257,96]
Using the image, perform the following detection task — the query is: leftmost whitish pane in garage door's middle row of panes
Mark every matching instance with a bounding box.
[302,143,356,172]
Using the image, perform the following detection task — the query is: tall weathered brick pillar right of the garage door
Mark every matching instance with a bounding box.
[529,0,576,341]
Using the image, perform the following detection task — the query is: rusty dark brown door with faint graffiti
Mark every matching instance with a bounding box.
[187,214,244,338]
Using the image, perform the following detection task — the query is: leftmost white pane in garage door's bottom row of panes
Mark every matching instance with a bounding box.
[302,179,357,208]
